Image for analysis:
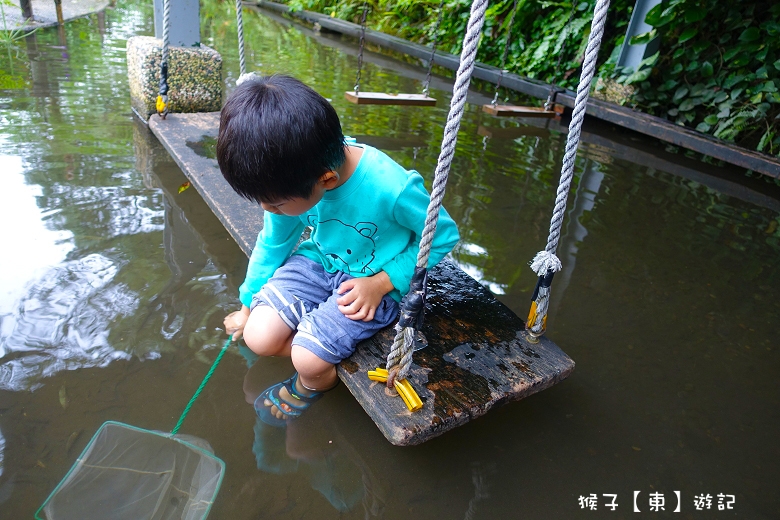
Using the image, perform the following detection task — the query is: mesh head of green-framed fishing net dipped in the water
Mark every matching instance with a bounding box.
[35,421,225,520]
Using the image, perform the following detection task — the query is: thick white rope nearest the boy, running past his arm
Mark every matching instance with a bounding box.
[387,0,488,387]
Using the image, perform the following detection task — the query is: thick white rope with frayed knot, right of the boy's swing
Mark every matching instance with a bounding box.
[527,0,609,336]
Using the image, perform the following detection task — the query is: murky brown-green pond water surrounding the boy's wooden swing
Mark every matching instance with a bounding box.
[0,2,780,519]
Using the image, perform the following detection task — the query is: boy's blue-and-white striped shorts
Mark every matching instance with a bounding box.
[250,255,398,365]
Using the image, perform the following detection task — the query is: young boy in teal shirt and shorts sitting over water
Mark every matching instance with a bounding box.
[217,75,458,426]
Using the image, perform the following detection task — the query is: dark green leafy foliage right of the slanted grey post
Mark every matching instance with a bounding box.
[602,0,780,155]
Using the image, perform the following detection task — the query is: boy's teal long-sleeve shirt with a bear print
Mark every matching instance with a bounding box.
[239,145,459,307]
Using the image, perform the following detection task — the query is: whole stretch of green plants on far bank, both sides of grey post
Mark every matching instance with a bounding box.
[278,0,780,156]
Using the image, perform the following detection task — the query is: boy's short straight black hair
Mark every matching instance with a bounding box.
[217,75,346,202]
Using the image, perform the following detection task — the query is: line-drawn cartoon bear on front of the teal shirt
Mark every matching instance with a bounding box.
[308,215,377,275]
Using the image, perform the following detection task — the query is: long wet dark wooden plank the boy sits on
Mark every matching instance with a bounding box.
[149,113,574,446]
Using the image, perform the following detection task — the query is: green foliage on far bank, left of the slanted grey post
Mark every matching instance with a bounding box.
[286,0,634,87]
